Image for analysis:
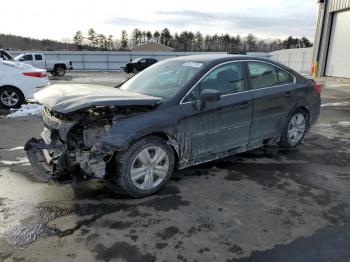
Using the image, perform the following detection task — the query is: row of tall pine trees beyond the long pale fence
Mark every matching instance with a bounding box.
[73,28,312,53]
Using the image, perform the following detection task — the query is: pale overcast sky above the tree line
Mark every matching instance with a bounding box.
[0,0,317,40]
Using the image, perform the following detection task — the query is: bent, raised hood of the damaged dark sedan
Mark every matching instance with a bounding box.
[34,84,162,114]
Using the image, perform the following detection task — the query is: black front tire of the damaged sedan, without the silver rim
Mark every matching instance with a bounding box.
[111,136,175,198]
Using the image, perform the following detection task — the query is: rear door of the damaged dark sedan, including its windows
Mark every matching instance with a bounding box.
[246,61,295,146]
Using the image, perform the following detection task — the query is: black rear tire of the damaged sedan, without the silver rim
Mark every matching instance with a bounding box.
[279,108,309,148]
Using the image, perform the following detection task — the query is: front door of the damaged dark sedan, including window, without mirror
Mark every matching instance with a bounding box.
[180,62,252,163]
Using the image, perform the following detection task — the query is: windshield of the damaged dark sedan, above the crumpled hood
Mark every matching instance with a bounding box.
[121,60,203,98]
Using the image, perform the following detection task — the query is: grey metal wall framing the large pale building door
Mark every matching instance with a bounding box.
[312,0,350,76]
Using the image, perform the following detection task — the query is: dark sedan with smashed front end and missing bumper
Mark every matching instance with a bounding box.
[25,55,321,197]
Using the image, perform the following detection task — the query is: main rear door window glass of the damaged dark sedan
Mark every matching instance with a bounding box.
[248,62,278,89]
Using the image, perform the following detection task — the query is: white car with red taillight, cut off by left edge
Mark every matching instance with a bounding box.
[0,58,49,108]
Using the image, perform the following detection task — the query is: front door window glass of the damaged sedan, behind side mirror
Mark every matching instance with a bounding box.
[184,63,244,102]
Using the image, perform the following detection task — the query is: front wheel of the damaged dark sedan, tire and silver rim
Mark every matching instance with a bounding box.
[113,136,175,197]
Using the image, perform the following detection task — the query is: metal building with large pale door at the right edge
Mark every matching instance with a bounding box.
[313,0,350,78]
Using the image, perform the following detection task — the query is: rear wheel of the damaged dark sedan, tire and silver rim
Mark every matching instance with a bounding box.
[279,109,308,148]
